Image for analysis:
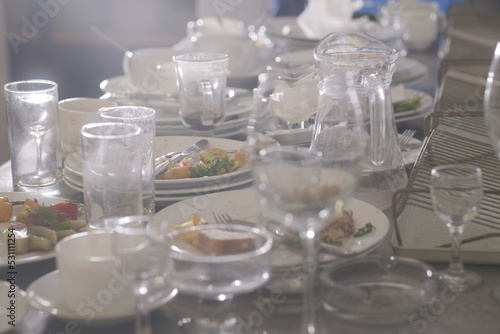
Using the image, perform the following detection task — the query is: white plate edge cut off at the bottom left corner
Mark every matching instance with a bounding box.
[0,277,28,333]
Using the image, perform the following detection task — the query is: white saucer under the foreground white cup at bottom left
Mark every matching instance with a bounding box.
[27,270,177,326]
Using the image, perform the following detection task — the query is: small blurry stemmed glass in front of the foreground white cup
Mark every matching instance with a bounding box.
[114,216,174,334]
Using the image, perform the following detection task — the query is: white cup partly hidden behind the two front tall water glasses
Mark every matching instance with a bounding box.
[58,97,117,159]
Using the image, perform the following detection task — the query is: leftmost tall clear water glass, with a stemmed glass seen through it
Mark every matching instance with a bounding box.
[4,80,62,192]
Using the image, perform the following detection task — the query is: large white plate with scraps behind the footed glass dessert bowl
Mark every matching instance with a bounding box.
[155,188,390,267]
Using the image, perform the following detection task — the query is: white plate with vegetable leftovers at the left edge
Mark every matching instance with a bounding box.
[0,192,85,267]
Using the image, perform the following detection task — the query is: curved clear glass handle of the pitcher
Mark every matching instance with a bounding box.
[363,73,387,166]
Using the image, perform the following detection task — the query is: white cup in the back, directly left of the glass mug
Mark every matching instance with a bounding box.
[122,47,185,95]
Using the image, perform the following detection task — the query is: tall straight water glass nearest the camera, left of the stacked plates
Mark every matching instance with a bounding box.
[81,123,143,228]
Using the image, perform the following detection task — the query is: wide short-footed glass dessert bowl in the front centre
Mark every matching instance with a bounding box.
[167,224,273,334]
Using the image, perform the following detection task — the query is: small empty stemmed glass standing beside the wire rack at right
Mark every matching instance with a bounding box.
[430,165,483,292]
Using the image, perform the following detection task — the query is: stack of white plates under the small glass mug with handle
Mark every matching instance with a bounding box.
[100,76,253,138]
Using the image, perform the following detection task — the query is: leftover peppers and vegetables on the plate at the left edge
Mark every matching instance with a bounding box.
[0,197,86,255]
